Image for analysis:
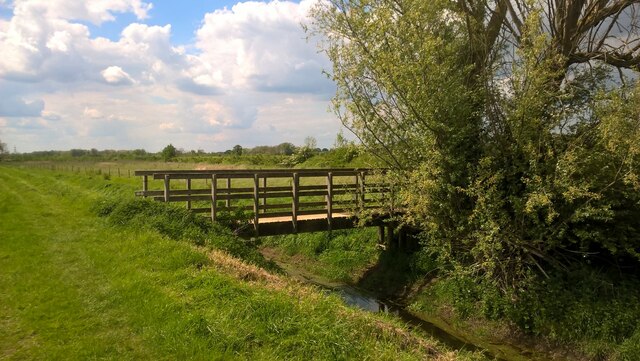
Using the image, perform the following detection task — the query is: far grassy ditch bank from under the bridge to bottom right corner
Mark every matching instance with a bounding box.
[264,230,640,361]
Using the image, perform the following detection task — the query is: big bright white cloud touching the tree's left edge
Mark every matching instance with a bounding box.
[191,0,333,93]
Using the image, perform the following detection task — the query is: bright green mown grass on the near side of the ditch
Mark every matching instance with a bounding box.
[0,167,472,360]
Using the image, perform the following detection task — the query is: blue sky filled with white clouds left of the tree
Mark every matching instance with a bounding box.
[0,0,341,152]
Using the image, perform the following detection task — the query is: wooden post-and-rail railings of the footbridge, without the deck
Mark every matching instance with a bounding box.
[135,168,389,234]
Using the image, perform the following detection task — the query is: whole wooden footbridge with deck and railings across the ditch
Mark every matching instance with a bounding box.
[135,169,391,237]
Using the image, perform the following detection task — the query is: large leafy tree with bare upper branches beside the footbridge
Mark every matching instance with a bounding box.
[311,0,640,284]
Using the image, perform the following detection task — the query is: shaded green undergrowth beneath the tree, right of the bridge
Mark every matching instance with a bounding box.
[413,267,640,360]
